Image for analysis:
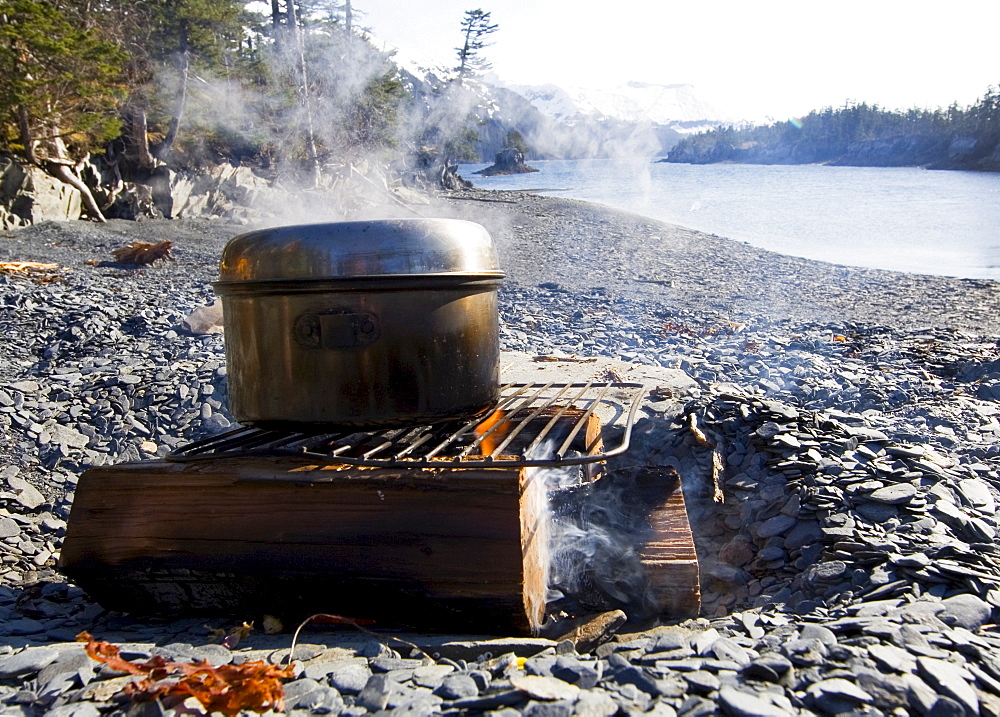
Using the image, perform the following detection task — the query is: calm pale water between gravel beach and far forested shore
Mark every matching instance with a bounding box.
[461,160,1000,279]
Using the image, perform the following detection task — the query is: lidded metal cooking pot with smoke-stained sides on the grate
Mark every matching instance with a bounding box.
[213,219,504,428]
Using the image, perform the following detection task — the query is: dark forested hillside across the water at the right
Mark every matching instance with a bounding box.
[665,87,1000,171]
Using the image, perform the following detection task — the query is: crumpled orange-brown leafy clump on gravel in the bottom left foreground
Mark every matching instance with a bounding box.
[77,632,295,715]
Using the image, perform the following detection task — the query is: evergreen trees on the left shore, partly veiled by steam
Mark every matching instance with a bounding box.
[0,0,489,219]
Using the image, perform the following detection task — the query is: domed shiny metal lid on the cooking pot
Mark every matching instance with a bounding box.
[219,219,503,282]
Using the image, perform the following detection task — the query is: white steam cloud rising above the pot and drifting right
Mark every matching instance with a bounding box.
[148,18,672,231]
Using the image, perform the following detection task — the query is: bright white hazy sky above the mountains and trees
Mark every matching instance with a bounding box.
[353,0,1000,119]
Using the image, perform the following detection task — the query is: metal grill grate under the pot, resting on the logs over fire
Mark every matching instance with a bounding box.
[167,381,643,468]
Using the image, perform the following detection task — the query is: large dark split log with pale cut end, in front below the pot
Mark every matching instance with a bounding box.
[60,457,547,633]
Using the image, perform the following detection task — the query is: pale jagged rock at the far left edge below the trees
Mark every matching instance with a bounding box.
[0,156,83,229]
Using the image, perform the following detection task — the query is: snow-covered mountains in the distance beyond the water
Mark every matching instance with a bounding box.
[504,82,732,131]
